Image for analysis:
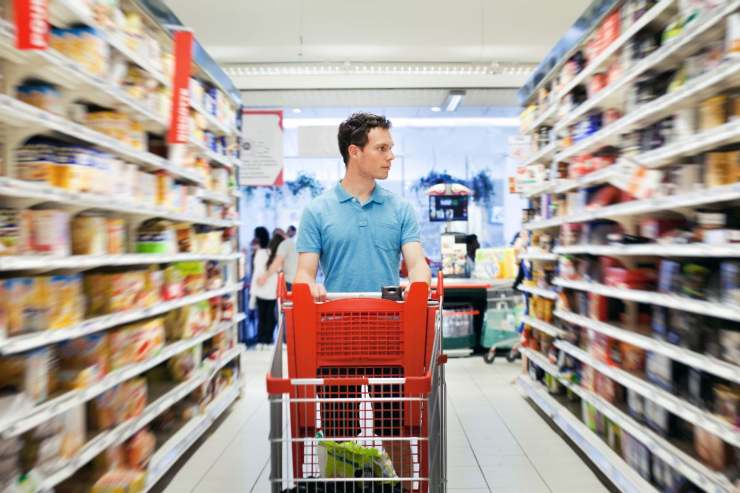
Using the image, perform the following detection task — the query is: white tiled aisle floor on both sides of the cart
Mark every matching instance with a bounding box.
[159,351,608,493]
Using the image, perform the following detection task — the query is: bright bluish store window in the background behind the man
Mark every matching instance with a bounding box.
[242,109,521,259]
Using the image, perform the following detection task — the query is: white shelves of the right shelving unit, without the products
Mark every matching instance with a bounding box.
[519,0,740,493]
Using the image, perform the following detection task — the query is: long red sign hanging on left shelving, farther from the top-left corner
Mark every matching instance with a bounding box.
[167,31,193,144]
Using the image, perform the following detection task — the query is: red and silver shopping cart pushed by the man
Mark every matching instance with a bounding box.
[267,276,447,493]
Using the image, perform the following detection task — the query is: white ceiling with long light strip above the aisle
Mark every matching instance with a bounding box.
[165,0,590,94]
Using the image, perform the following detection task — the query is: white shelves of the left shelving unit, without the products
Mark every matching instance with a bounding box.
[0,0,249,492]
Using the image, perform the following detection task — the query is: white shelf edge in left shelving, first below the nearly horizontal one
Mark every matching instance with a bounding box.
[0,283,242,355]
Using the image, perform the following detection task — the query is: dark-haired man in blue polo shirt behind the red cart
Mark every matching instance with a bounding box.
[295,113,431,299]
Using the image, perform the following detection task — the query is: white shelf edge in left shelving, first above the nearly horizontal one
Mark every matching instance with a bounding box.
[0,177,238,228]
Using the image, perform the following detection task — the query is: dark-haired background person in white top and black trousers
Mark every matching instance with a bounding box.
[249,234,283,347]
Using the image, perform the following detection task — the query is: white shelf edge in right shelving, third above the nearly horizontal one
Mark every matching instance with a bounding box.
[555,58,740,161]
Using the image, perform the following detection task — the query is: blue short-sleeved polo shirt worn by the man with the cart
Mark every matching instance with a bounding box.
[296,183,421,293]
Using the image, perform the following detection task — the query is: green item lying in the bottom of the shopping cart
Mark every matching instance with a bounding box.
[318,434,398,484]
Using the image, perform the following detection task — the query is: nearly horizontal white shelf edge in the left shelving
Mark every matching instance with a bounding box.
[0,253,241,272]
